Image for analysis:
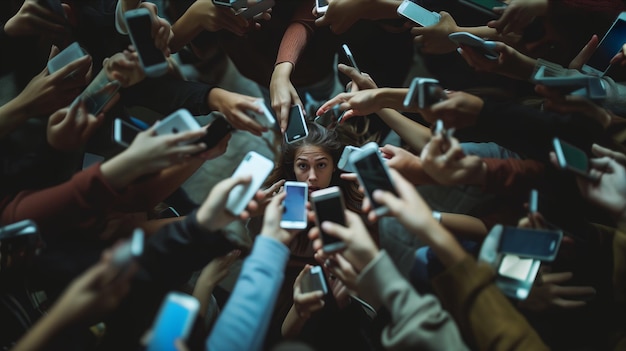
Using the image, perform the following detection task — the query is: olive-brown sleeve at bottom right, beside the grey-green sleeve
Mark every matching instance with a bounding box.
[433,256,548,350]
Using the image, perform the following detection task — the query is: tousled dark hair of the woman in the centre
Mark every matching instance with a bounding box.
[265,122,367,212]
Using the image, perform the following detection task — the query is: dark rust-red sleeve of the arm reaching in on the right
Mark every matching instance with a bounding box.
[483,158,545,194]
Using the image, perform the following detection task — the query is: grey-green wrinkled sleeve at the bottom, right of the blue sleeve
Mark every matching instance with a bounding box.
[357,251,467,350]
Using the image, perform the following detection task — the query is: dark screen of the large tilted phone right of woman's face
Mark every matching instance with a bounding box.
[354,152,397,207]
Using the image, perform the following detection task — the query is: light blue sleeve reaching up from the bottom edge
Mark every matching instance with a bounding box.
[206,235,289,351]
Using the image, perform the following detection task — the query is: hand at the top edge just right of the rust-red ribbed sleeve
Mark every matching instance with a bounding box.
[313,0,376,34]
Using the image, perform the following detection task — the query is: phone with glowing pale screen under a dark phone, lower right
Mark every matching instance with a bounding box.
[496,254,541,300]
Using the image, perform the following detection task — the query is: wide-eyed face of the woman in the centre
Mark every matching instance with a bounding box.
[293,145,335,193]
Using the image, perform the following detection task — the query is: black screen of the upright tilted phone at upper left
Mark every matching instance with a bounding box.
[126,15,165,67]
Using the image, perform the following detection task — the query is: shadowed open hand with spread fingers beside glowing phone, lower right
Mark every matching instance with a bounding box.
[519,272,596,312]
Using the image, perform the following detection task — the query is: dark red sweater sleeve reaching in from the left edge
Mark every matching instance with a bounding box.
[0,164,119,239]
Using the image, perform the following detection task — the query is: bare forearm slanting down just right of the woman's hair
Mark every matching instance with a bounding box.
[377,108,431,152]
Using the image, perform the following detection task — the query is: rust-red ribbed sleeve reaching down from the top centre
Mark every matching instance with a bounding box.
[275,1,315,67]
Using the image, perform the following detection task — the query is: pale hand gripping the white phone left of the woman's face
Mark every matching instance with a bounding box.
[196,176,258,231]
